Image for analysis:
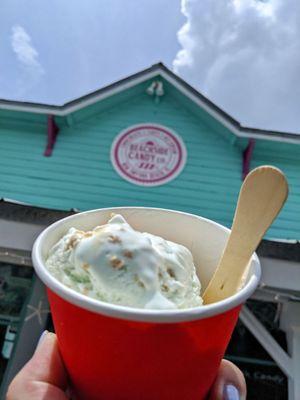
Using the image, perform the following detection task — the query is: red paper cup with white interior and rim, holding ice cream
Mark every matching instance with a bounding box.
[33,207,261,400]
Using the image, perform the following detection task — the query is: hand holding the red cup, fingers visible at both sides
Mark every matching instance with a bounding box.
[6,332,246,400]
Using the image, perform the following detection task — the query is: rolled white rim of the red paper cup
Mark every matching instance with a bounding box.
[32,207,261,323]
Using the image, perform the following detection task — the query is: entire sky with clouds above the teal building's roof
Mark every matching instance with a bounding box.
[0,0,300,133]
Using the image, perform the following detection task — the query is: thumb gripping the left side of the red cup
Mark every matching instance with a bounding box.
[6,332,68,400]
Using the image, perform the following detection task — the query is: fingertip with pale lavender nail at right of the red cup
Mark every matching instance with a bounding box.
[209,360,247,400]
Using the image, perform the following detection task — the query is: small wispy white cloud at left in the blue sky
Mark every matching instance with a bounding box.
[11,25,45,96]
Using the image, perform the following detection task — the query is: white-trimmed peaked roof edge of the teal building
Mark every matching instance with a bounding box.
[0,63,300,144]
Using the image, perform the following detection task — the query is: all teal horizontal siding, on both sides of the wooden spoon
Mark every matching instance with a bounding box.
[0,78,300,239]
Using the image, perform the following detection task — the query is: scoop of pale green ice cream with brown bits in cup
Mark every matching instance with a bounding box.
[46,215,202,309]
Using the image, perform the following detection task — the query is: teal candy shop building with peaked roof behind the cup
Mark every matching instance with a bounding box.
[0,64,300,399]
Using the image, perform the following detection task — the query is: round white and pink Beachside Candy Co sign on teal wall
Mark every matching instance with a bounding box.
[111,124,186,186]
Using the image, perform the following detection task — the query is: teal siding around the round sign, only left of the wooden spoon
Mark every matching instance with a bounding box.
[0,93,241,231]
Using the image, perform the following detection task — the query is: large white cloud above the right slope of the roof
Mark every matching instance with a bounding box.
[173,0,300,132]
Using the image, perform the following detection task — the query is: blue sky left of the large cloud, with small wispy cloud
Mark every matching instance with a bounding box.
[0,0,185,104]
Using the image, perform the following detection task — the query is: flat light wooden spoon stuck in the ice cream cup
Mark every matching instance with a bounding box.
[203,166,288,304]
